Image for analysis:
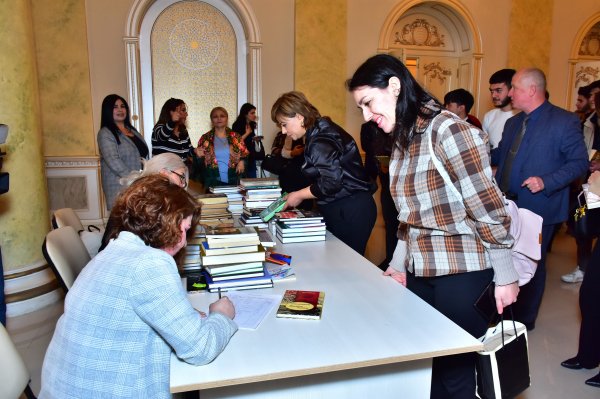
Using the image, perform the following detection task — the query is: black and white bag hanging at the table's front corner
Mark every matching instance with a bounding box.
[476,308,531,399]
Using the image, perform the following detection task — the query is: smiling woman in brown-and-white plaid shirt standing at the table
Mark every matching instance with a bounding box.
[347,54,519,399]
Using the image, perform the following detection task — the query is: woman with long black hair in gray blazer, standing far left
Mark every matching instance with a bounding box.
[98,94,149,210]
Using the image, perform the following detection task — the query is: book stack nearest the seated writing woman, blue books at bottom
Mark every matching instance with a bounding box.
[200,227,273,292]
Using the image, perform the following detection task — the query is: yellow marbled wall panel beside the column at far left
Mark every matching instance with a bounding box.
[32,0,96,156]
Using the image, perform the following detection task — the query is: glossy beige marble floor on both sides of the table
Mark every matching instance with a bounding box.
[7,227,600,399]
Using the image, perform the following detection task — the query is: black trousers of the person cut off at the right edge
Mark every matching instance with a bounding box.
[577,241,600,368]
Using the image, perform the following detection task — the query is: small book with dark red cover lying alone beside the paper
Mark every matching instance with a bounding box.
[277,290,325,320]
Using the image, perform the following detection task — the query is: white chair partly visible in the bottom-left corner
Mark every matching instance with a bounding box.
[0,324,35,399]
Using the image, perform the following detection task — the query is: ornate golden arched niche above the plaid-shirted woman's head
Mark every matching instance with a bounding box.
[378,0,483,113]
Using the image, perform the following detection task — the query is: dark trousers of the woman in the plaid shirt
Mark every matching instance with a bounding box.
[406,269,494,399]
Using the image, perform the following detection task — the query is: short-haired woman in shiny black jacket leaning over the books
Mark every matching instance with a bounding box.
[271,91,377,255]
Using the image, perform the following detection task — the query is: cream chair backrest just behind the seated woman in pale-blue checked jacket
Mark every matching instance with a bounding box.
[42,226,90,292]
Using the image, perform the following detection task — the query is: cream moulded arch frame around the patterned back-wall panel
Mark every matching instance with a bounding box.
[123,0,262,144]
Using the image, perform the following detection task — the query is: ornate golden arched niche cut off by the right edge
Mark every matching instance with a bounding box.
[566,12,600,110]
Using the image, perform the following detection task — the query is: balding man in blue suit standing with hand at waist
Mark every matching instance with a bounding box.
[493,68,588,330]
